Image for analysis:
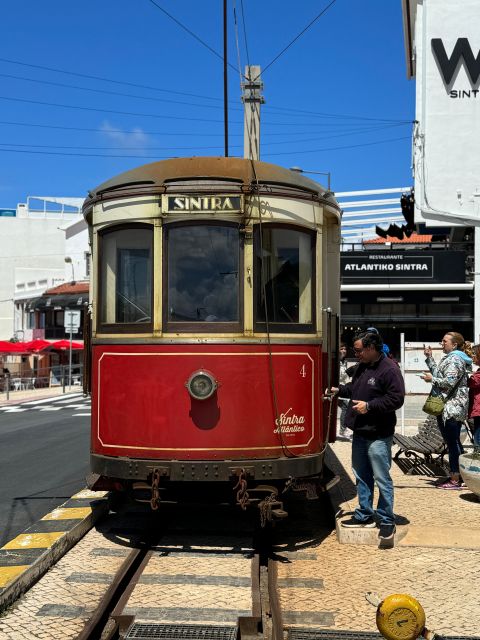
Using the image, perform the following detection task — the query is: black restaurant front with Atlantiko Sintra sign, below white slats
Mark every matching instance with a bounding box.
[340,233,473,355]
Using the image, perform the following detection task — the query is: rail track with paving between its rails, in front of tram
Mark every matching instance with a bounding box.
[79,488,334,640]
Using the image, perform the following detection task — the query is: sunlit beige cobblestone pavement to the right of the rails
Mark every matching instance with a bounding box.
[278,442,480,636]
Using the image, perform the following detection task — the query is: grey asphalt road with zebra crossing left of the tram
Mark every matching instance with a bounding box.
[0,395,90,547]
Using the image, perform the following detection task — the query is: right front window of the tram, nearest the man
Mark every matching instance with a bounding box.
[255,226,314,331]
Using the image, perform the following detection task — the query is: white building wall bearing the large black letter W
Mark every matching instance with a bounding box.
[414,0,480,224]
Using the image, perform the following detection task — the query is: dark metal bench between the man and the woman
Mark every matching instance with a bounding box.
[393,416,448,476]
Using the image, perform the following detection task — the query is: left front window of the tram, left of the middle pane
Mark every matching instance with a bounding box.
[101,228,152,325]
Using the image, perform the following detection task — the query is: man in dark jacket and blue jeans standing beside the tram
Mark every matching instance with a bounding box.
[332,331,405,542]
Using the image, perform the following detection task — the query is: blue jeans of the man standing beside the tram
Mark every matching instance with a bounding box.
[352,432,395,524]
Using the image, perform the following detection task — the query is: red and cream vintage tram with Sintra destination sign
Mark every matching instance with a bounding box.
[83,158,340,513]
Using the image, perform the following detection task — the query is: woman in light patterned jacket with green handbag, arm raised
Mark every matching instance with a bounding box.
[422,331,472,489]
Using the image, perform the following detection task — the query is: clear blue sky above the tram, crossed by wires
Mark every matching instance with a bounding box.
[0,0,414,208]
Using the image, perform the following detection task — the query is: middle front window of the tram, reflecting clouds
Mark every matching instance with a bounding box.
[166,224,240,330]
